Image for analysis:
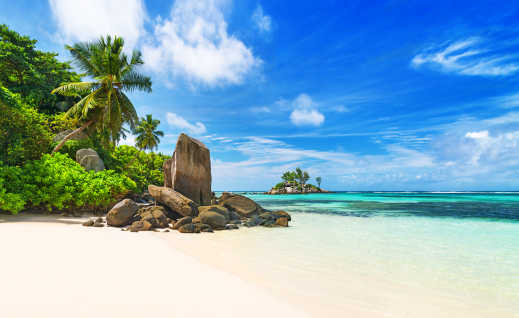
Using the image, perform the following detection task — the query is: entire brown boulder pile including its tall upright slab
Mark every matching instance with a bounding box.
[83,134,291,233]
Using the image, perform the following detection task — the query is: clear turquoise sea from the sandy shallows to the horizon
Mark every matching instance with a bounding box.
[171,192,519,317]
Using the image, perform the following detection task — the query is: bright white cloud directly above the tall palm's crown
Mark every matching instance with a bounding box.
[49,0,146,50]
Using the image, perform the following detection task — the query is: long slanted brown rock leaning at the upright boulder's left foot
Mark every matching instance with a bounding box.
[148,184,198,216]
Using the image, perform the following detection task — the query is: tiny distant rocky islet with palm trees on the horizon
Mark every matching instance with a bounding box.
[265,168,329,194]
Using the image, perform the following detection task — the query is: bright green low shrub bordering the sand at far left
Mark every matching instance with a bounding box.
[0,153,136,214]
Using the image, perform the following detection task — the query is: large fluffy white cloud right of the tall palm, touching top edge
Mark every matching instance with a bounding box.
[142,0,262,86]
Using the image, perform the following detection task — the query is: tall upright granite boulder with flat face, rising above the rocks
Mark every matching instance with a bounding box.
[163,134,212,205]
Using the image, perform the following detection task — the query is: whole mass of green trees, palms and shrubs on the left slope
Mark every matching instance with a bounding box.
[0,25,168,213]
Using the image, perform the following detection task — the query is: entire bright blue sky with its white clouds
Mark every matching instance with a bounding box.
[0,0,519,191]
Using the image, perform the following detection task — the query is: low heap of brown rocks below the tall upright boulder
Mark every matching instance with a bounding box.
[83,190,291,233]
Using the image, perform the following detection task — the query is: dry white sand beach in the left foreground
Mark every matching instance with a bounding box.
[0,215,307,318]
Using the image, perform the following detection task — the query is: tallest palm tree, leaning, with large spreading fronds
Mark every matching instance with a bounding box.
[52,36,151,153]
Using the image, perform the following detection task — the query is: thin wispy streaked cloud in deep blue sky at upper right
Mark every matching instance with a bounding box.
[411,38,519,76]
